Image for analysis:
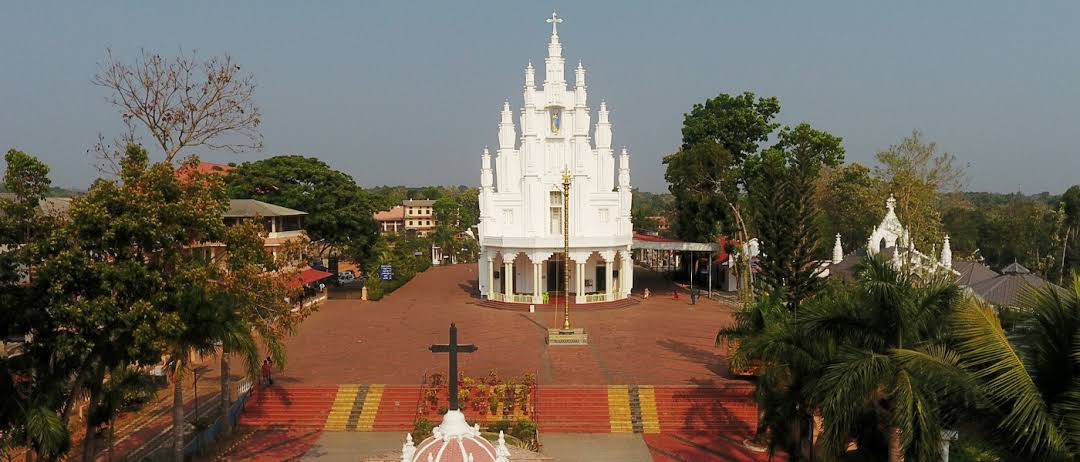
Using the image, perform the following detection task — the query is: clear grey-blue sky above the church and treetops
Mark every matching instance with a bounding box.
[0,1,1080,192]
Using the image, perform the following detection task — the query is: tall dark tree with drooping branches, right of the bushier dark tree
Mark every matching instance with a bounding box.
[745,123,843,310]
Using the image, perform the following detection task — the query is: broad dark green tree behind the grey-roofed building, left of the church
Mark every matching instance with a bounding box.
[226,155,378,258]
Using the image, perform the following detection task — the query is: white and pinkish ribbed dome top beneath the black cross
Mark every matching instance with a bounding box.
[402,410,510,462]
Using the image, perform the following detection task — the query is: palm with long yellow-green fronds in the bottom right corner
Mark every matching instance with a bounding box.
[950,274,1080,461]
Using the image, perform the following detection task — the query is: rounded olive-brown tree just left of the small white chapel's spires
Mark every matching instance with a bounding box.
[816,163,885,250]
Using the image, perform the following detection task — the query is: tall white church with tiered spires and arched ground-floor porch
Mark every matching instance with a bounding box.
[480,13,634,303]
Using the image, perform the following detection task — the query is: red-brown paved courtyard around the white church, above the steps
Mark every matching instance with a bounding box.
[278,264,732,386]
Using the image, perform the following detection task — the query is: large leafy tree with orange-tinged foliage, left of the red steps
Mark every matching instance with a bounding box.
[18,146,227,460]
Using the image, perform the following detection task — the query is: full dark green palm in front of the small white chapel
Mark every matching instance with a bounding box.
[797,258,962,461]
